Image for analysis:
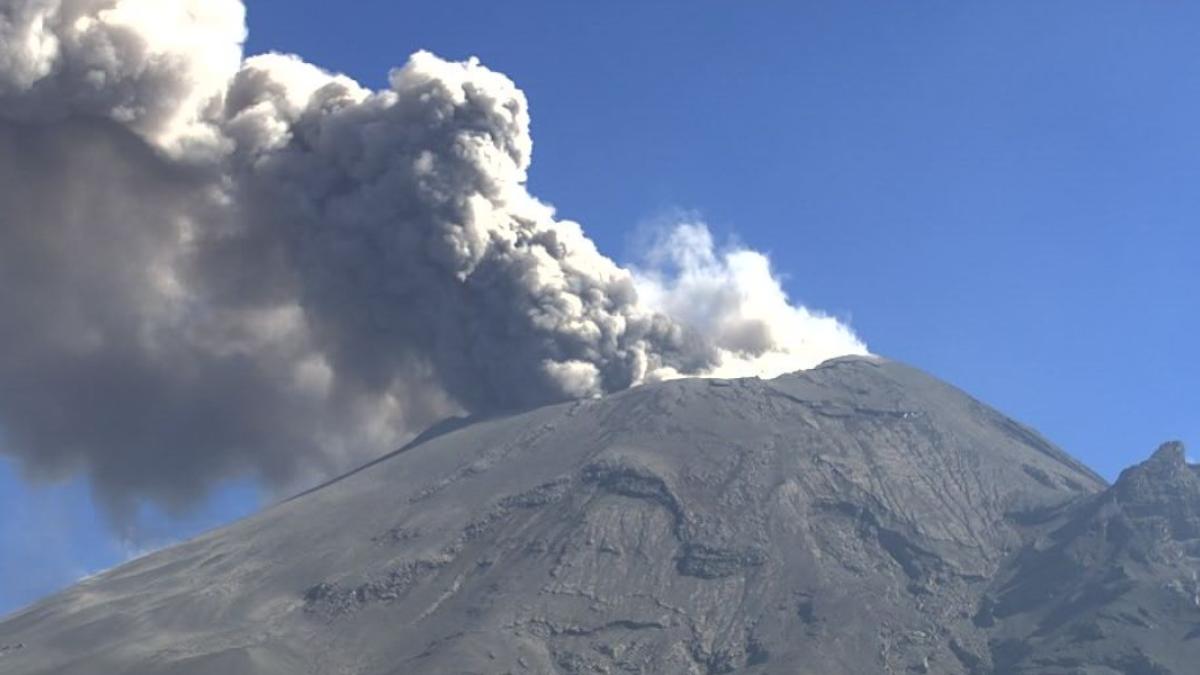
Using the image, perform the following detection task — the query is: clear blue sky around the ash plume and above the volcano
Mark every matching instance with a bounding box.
[0,0,1200,613]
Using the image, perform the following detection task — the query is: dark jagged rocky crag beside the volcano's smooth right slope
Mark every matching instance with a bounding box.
[980,443,1200,675]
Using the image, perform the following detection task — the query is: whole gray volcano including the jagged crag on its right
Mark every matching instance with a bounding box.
[0,358,1200,675]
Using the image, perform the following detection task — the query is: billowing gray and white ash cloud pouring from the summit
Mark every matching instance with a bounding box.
[0,0,864,509]
